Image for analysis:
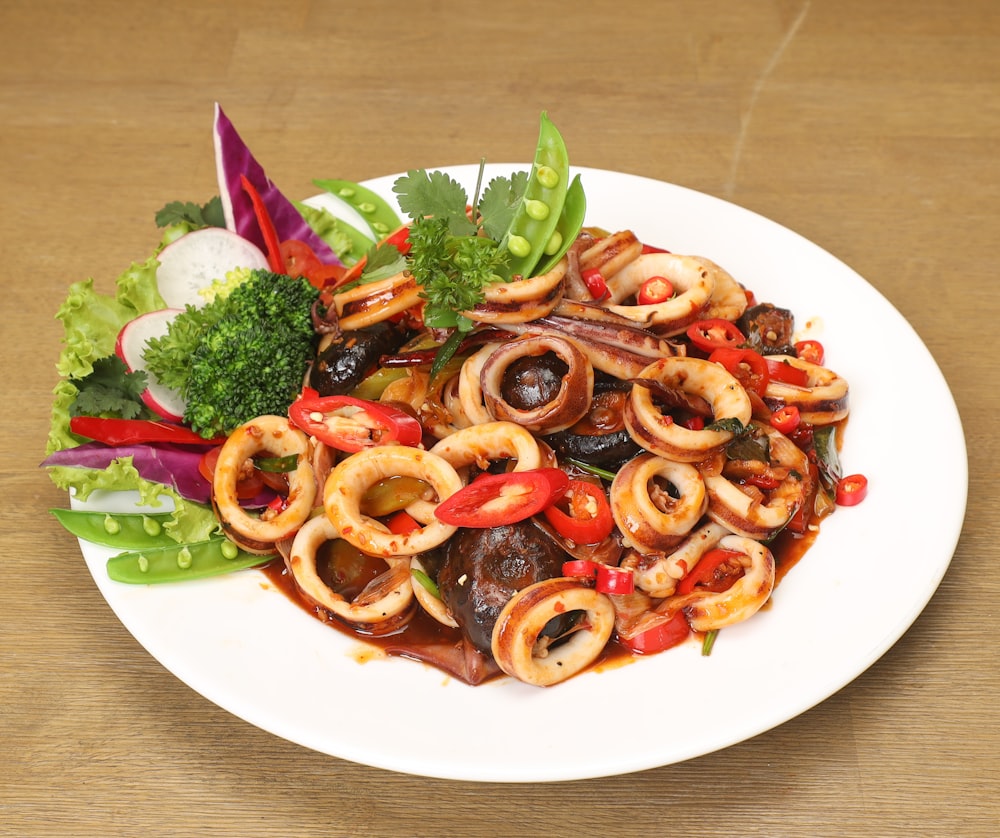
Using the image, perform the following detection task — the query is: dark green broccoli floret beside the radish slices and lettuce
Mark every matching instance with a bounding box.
[166,271,319,437]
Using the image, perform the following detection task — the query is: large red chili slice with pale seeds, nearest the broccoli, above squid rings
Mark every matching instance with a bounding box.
[288,387,423,453]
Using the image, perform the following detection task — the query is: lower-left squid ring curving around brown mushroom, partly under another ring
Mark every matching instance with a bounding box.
[285,515,414,635]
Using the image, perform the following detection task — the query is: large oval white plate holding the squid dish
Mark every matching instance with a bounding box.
[70,165,968,782]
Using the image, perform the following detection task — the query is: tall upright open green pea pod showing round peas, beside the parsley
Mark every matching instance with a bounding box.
[500,112,569,277]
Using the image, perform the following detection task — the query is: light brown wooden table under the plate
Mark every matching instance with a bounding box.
[0,0,1000,836]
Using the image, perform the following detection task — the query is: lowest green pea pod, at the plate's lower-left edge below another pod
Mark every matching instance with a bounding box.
[107,536,274,585]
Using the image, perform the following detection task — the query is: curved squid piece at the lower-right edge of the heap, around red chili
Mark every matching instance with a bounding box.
[663,535,775,631]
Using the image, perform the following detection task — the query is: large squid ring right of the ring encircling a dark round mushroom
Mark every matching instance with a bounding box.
[625,357,752,463]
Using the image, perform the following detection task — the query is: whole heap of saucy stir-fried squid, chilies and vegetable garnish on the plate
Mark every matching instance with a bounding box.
[43,106,867,686]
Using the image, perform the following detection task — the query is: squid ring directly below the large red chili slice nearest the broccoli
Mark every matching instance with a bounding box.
[323,445,463,557]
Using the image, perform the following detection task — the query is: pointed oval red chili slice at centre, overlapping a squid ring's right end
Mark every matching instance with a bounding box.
[434,468,569,529]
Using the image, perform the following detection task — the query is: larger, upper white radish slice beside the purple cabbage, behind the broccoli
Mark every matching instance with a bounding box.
[156,227,267,308]
